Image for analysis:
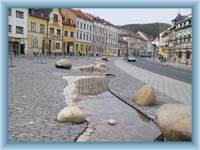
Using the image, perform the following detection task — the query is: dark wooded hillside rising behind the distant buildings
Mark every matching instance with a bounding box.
[118,23,170,39]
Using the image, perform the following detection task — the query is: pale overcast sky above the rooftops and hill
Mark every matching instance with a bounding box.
[81,8,192,25]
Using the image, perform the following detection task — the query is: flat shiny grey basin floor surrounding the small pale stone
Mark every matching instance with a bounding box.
[79,91,161,142]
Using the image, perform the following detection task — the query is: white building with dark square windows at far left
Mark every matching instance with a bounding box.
[8,8,28,55]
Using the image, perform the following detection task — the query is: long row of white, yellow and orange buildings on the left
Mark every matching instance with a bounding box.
[8,8,122,56]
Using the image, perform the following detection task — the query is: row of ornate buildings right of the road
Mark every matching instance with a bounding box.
[156,13,192,65]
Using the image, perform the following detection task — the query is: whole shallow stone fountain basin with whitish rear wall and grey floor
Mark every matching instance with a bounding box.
[63,75,161,142]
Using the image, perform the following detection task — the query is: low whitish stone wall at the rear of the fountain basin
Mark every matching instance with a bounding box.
[63,76,111,105]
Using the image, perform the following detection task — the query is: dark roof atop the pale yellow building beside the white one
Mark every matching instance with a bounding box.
[28,8,52,19]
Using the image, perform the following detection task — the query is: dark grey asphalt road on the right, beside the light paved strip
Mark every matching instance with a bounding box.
[130,58,192,84]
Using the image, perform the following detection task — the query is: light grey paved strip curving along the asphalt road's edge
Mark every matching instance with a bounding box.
[115,59,192,104]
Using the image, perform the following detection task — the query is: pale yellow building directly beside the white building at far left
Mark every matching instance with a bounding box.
[28,9,48,55]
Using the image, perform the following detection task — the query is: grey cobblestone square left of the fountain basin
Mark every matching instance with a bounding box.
[8,57,98,142]
